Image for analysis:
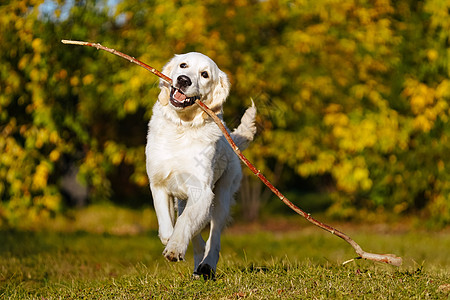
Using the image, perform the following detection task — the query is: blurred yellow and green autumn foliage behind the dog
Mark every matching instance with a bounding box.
[0,0,450,227]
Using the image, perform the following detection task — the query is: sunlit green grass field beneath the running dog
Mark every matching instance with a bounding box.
[0,207,450,299]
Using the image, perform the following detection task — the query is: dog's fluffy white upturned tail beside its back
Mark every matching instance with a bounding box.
[231,101,256,150]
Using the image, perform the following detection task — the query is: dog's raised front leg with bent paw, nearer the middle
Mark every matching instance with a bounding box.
[163,188,214,261]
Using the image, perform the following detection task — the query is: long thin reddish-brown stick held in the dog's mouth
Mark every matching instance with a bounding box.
[61,40,402,266]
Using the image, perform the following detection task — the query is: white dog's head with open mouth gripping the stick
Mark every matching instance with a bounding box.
[158,52,230,119]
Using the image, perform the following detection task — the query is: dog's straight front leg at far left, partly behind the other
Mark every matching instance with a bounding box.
[150,185,175,245]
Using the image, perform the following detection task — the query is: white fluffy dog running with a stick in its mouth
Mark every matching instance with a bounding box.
[146,52,256,278]
